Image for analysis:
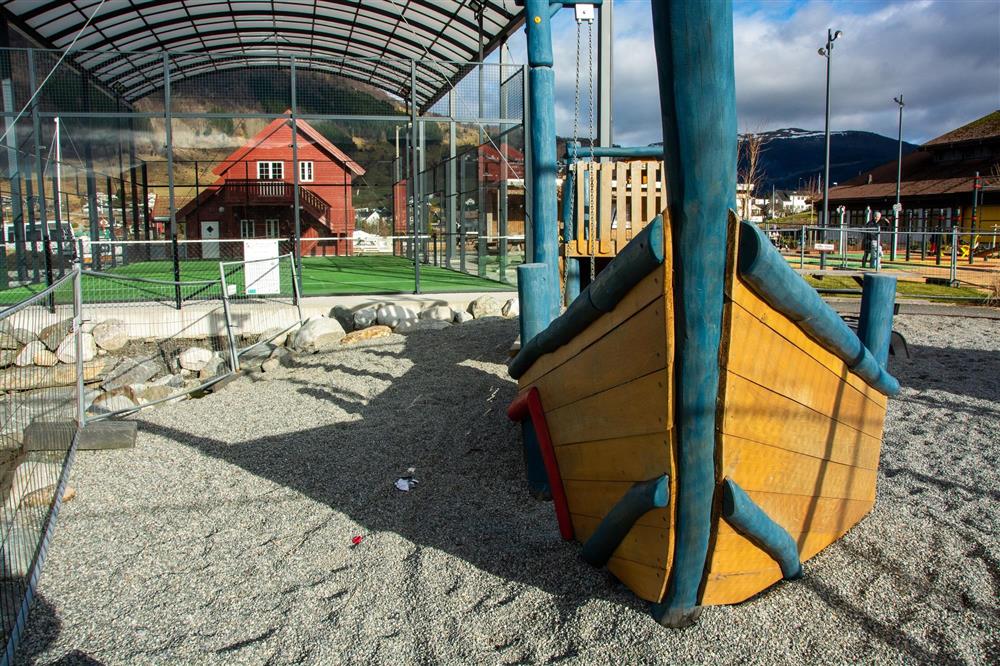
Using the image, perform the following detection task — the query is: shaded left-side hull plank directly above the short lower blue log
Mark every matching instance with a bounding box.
[555,432,673,481]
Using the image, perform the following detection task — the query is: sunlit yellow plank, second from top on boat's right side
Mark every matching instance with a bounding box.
[727,304,885,438]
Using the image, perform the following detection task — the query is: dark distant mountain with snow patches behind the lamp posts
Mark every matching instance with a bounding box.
[758,127,918,192]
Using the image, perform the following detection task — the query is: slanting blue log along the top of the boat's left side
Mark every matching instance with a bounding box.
[508,215,663,379]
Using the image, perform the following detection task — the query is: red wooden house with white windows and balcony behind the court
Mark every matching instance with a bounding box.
[177,118,365,258]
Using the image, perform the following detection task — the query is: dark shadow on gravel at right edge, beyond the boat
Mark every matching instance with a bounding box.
[890,345,1000,402]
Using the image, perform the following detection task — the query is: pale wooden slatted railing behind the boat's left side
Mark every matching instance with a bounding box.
[563,161,667,257]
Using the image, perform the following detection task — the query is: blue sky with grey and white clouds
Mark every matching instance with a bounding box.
[498,0,1000,145]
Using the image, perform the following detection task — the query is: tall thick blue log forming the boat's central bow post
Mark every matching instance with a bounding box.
[652,0,737,627]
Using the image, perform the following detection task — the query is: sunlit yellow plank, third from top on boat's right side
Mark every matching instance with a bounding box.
[720,373,881,469]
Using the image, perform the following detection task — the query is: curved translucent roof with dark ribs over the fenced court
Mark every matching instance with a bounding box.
[0,0,523,107]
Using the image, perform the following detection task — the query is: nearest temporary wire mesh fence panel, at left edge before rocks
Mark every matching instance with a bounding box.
[0,270,82,663]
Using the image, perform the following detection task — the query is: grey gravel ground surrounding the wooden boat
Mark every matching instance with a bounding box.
[13,317,1000,664]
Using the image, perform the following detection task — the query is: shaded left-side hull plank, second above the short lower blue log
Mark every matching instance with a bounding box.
[542,369,671,446]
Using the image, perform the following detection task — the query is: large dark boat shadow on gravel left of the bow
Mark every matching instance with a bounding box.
[139,319,645,616]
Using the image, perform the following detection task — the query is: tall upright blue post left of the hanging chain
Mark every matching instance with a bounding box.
[521,0,559,325]
